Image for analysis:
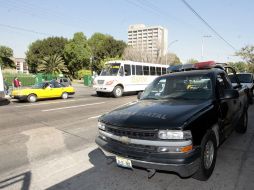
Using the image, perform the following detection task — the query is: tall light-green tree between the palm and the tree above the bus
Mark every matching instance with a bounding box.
[64,32,91,77]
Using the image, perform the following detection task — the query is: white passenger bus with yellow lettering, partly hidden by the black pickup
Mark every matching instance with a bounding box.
[93,60,168,97]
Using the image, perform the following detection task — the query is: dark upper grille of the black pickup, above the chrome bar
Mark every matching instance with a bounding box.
[106,125,158,140]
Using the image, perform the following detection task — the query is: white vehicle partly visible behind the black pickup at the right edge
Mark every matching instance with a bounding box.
[229,73,254,104]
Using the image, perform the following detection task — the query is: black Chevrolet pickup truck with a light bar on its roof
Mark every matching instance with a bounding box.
[96,63,248,180]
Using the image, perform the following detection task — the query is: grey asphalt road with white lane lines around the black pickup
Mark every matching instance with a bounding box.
[0,85,254,190]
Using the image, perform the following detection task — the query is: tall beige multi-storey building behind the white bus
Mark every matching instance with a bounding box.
[128,24,168,62]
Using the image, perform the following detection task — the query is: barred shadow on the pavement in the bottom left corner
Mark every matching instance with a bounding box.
[0,171,32,190]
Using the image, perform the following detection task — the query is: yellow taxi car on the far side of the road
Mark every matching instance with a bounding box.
[11,80,75,102]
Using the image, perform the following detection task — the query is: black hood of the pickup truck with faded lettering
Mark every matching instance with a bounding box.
[99,100,213,129]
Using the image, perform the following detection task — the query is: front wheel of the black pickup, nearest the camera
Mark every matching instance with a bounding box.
[192,130,217,181]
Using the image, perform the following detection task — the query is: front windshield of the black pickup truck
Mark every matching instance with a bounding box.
[141,74,213,100]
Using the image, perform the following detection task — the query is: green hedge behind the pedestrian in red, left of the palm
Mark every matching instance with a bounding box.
[3,73,36,86]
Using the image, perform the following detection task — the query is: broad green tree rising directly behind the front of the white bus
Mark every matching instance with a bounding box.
[88,33,126,70]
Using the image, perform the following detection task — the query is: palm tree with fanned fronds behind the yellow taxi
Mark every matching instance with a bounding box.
[38,54,68,75]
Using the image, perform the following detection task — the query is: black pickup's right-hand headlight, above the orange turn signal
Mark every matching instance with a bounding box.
[158,130,192,139]
